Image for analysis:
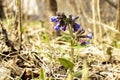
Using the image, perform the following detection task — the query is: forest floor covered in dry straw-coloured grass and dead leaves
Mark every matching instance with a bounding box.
[0,20,120,80]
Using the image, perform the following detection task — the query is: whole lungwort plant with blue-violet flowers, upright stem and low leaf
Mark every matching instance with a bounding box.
[50,13,93,80]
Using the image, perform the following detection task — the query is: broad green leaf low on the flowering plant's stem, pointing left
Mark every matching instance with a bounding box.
[58,58,75,70]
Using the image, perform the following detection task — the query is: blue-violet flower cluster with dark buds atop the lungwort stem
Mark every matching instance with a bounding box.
[50,13,93,45]
